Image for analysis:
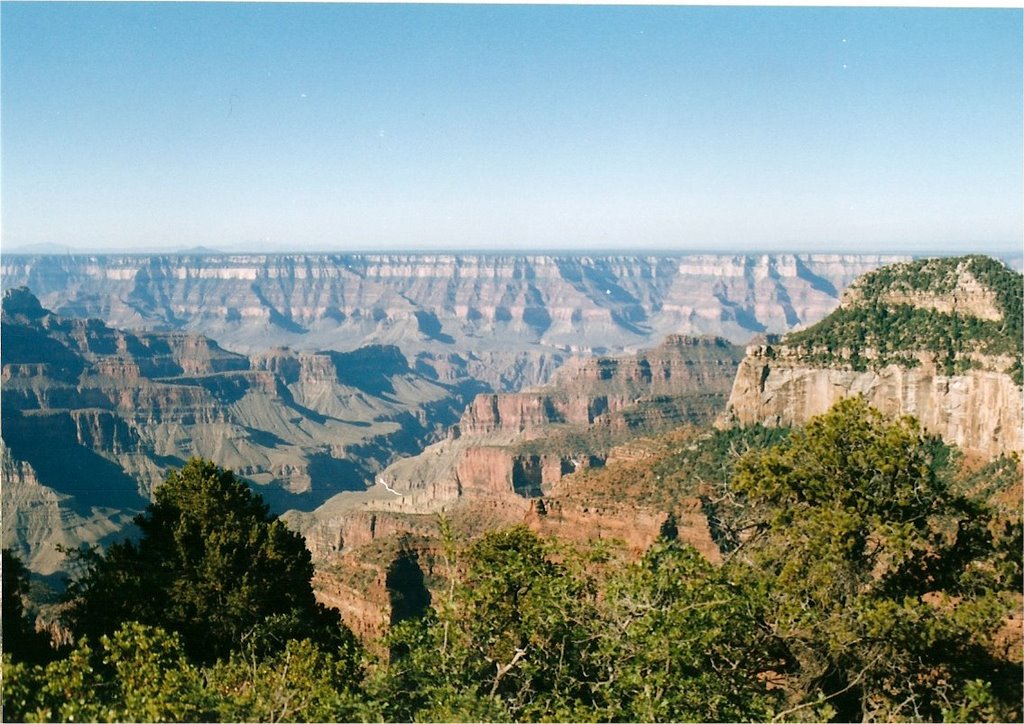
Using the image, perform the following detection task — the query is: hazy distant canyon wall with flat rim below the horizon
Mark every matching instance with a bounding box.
[0,254,895,389]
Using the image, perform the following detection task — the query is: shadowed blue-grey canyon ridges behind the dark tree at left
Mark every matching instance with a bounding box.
[0,289,477,573]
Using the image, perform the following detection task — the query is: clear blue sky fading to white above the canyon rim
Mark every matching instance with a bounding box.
[0,2,1024,252]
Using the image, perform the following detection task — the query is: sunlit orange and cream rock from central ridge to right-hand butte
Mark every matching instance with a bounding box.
[290,253,1024,635]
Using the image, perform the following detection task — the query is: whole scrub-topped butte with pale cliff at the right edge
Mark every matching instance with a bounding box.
[727,257,1024,457]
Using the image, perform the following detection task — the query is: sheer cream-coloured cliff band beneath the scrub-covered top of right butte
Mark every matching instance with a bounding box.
[728,345,1024,457]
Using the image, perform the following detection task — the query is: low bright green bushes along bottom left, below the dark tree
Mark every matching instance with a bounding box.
[3,623,370,722]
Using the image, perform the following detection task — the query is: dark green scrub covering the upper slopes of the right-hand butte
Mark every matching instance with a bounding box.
[784,256,1024,384]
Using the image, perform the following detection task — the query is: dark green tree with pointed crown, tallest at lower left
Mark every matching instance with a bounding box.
[67,460,351,663]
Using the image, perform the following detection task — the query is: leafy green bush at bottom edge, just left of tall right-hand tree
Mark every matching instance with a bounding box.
[589,543,780,721]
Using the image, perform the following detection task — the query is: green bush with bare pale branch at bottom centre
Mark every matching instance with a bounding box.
[372,526,594,721]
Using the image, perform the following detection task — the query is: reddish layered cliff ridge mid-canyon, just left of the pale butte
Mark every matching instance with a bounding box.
[379,335,740,504]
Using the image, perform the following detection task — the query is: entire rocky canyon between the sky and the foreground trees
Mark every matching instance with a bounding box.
[0,255,1024,635]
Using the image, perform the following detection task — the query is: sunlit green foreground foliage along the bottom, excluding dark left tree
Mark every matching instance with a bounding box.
[3,405,1022,721]
